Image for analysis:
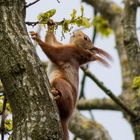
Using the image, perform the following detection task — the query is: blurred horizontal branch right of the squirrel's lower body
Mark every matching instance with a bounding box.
[77,98,121,111]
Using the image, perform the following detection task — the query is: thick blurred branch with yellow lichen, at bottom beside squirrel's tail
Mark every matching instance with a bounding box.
[69,111,111,140]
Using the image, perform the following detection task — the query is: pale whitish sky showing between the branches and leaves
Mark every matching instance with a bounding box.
[26,0,140,140]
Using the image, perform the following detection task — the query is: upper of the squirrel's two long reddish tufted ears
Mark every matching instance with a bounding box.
[90,46,113,61]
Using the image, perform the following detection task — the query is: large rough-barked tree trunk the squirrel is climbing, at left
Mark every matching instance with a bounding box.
[0,0,63,140]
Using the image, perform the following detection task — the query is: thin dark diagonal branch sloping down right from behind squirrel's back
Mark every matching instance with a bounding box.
[81,67,138,120]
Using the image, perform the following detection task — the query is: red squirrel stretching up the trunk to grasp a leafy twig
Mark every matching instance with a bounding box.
[30,22,111,140]
